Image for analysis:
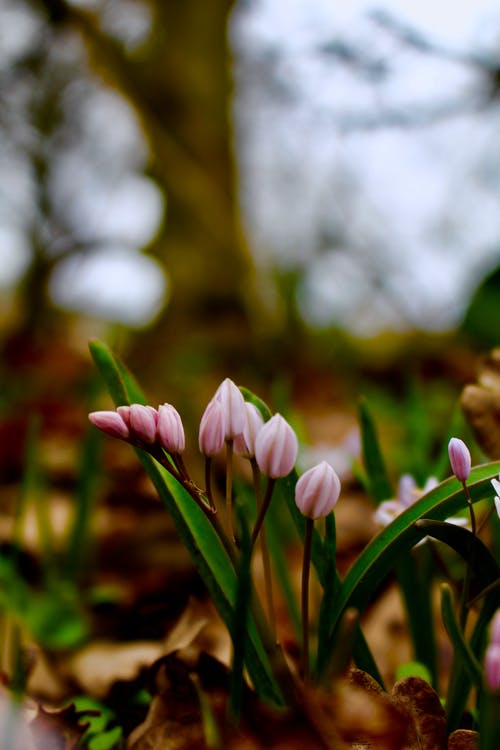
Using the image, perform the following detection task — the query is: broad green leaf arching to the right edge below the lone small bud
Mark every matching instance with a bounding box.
[322,468,500,680]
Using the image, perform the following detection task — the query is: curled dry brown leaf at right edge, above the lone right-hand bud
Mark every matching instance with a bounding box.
[461,348,500,459]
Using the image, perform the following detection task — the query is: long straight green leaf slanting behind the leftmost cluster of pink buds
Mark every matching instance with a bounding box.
[90,341,282,703]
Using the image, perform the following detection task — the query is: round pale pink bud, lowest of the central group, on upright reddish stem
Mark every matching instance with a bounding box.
[295,461,340,519]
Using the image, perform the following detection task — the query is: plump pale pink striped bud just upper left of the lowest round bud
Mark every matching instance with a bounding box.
[255,414,299,479]
